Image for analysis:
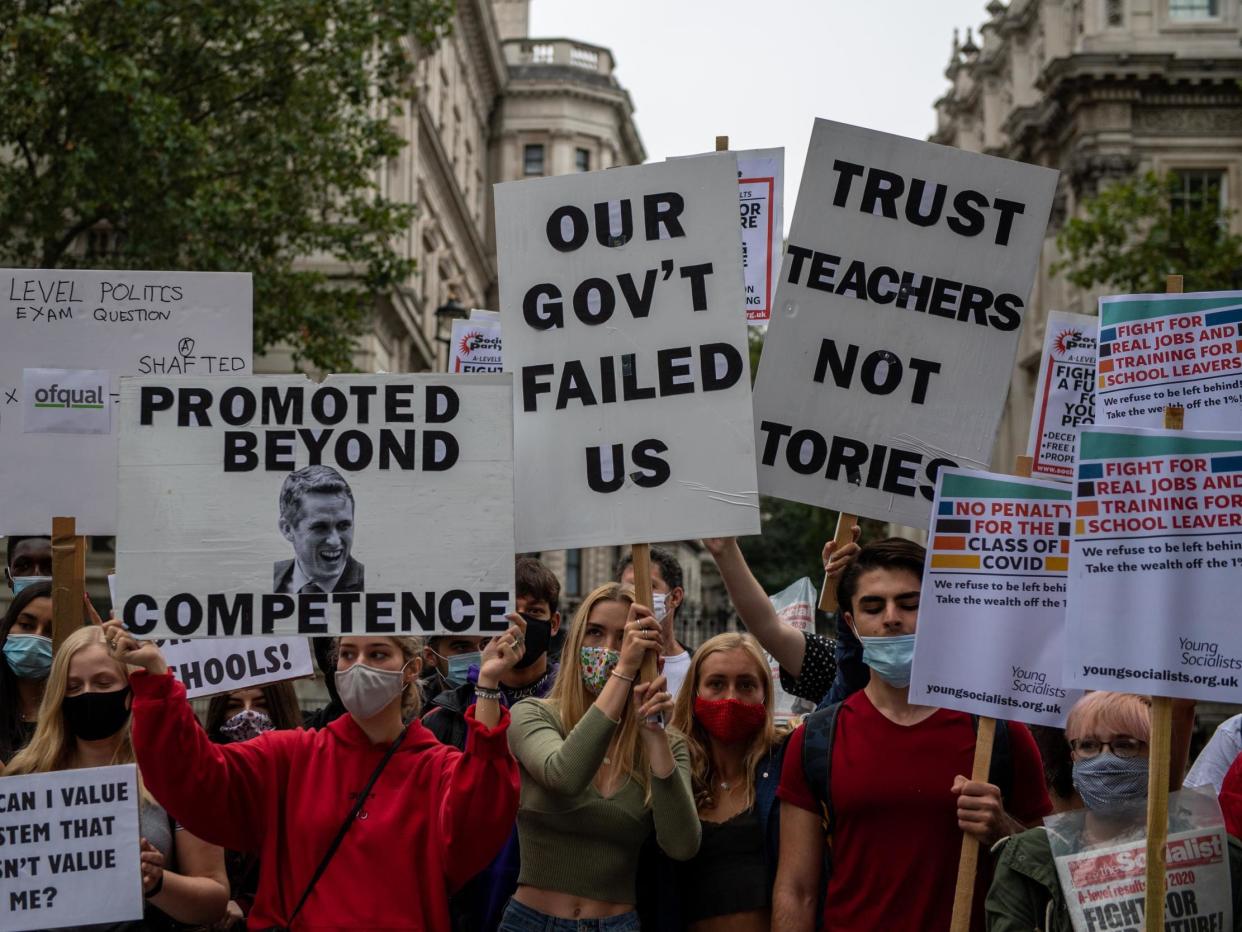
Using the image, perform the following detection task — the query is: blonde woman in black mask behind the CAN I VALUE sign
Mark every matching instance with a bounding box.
[4,623,229,932]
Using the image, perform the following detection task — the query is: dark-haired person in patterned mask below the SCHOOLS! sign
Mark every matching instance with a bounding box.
[204,680,302,928]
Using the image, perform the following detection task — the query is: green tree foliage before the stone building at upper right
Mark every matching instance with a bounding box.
[1053,174,1242,295]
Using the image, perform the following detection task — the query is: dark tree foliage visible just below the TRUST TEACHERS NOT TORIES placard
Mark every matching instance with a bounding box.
[738,327,888,594]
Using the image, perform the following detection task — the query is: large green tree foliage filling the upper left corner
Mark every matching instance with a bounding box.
[0,0,453,369]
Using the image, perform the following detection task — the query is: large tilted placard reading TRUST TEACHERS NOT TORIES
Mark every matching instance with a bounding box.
[754,119,1057,527]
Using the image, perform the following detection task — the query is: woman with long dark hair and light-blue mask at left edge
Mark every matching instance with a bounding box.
[0,584,52,765]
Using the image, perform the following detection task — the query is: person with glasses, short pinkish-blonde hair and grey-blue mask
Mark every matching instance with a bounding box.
[985,692,1242,932]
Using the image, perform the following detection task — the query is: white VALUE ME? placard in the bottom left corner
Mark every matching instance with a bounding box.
[0,764,143,932]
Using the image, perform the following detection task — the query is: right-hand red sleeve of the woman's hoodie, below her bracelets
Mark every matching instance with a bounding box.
[440,706,522,891]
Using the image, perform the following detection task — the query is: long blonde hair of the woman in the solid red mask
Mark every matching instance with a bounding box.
[673,633,776,811]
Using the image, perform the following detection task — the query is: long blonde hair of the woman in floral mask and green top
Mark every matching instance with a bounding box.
[535,583,651,795]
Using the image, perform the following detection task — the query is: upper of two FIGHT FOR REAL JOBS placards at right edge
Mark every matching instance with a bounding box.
[1095,291,1242,430]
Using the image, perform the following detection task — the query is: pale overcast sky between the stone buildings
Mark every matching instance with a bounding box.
[530,0,987,213]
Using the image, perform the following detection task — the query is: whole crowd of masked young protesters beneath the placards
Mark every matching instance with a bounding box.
[0,534,1242,932]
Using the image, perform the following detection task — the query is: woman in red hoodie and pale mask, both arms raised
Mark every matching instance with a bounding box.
[104,615,524,932]
